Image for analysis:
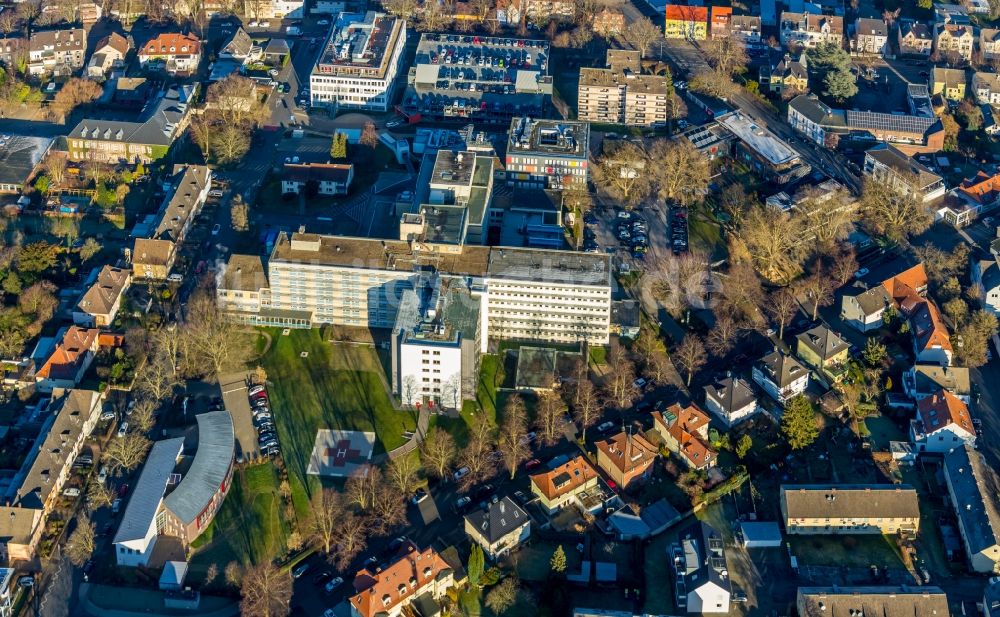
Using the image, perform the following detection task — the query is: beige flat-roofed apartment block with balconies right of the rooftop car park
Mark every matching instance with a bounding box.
[577,50,670,126]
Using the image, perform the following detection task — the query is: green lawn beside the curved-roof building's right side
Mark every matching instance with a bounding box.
[192,463,288,573]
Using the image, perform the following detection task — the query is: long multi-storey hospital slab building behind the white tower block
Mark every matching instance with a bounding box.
[217,232,611,351]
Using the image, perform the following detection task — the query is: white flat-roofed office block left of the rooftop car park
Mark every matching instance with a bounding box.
[309,11,406,111]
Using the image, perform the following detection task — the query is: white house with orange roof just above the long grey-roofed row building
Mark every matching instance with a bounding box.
[910,390,976,453]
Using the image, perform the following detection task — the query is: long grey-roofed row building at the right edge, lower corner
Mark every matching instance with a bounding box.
[944,445,1000,574]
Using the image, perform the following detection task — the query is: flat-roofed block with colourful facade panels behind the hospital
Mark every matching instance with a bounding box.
[506,117,590,189]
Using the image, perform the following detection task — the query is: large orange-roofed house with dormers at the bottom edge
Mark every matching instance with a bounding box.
[348,541,455,617]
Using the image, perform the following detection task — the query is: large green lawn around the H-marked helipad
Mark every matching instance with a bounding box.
[261,328,416,513]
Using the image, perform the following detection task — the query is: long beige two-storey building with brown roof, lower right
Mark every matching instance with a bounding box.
[781,484,920,535]
